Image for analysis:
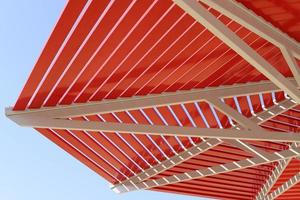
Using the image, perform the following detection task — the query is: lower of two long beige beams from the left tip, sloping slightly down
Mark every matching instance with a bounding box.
[10,113,300,142]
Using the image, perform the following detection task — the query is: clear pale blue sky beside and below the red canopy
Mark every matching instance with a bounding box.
[0,0,209,200]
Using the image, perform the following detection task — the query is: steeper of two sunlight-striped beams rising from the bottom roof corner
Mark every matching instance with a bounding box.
[110,100,296,192]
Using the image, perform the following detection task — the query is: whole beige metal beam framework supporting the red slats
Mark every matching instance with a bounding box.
[6,0,300,199]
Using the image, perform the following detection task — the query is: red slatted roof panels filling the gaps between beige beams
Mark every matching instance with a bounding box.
[14,0,300,199]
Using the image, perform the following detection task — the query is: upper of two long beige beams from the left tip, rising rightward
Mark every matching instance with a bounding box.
[6,79,296,118]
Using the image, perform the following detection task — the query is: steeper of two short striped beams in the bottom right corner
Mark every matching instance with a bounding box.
[255,159,291,200]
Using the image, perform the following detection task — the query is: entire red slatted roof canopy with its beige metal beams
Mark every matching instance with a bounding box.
[6,0,300,200]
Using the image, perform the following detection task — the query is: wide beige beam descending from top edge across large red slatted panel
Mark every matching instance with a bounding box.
[173,0,300,103]
